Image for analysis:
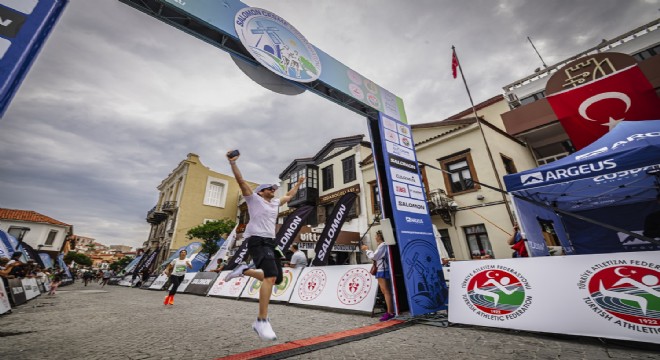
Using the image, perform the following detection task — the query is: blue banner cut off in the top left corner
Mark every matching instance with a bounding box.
[0,0,67,116]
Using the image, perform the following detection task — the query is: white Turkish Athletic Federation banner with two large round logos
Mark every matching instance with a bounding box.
[449,251,660,343]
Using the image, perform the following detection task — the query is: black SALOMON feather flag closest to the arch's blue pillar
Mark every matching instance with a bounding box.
[312,192,357,266]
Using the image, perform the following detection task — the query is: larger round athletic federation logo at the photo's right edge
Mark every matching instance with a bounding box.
[578,260,660,333]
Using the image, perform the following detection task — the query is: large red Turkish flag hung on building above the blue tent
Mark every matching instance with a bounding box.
[547,65,660,150]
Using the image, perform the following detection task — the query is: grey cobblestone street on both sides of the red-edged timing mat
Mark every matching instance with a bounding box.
[0,282,660,360]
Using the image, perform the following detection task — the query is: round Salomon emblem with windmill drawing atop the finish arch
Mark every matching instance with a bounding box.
[234,7,321,83]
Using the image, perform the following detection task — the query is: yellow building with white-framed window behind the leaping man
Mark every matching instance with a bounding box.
[143,153,256,263]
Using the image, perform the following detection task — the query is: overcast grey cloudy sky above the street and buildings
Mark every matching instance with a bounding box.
[0,0,660,246]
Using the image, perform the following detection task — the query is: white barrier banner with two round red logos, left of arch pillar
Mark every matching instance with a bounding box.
[289,264,378,312]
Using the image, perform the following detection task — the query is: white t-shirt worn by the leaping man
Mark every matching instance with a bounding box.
[243,193,280,239]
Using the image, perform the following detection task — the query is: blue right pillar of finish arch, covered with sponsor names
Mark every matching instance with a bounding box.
[371,113,447,315]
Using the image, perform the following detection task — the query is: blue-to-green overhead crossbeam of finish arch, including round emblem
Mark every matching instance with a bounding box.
[162,0,407,123]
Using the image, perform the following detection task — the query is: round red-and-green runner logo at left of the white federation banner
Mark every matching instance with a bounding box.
[463,265,532,321]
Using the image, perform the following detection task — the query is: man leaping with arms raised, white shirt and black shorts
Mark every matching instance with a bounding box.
[225,151,305,340]
